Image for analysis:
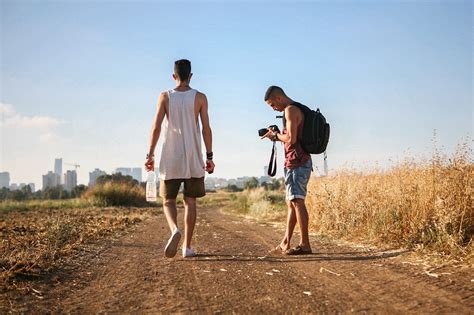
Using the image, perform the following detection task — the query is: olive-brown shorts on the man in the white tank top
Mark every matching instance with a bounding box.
[160,177,206,199]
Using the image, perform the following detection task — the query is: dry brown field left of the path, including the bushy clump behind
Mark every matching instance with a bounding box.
[0,183,156,285]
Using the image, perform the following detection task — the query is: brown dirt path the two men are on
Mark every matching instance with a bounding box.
[8,209,474,314]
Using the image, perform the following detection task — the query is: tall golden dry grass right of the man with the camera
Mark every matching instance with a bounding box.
[307,143,474,255]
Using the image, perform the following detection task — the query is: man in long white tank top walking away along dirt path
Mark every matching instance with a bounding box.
[145,59,214,258]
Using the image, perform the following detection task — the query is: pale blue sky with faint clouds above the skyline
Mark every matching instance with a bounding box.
[0,0,474,187]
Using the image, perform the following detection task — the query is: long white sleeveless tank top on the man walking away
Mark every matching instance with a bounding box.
[159,89,205,180]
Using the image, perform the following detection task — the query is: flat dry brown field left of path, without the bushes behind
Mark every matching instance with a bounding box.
[0,207,154,282]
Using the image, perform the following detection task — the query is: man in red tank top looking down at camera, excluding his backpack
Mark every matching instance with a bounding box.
[262,86,312,255]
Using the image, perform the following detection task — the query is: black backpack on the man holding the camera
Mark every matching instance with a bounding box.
[291,102,330,154]
